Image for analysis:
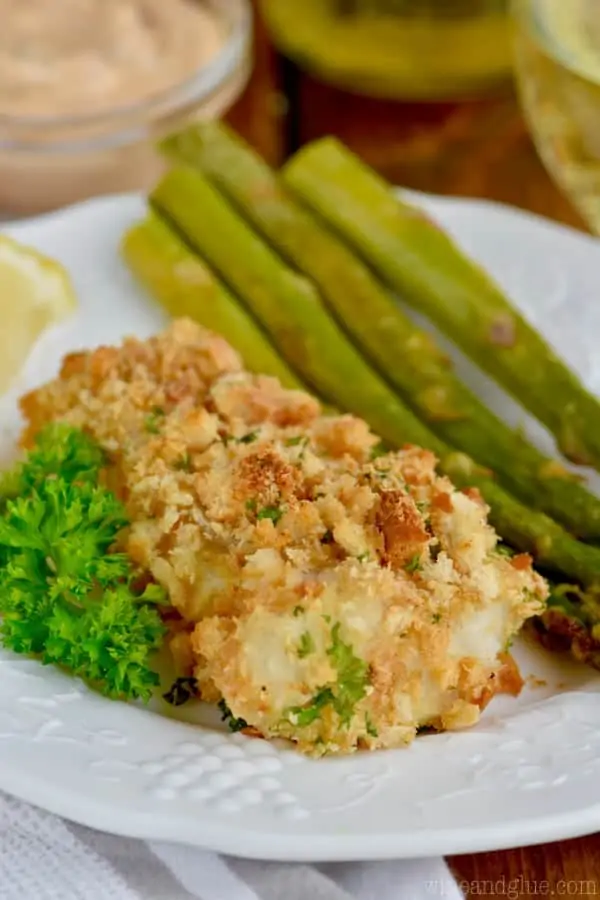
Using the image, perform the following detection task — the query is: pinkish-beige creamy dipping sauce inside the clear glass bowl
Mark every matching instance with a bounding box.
[0,0,226,118]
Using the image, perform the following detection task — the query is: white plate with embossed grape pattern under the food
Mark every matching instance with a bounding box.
[0,190,600,861]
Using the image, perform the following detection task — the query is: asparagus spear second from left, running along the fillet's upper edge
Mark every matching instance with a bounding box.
[151,168,600,586]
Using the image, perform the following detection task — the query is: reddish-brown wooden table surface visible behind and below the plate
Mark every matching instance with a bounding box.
[228,5,600,900]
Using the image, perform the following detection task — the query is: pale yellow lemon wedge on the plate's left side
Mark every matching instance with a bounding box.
[0,234,78,395]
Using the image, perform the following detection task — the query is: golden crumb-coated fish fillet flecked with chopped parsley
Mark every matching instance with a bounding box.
[22,320,547,754]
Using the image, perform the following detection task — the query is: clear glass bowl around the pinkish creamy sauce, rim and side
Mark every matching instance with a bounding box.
[0,0,252,215]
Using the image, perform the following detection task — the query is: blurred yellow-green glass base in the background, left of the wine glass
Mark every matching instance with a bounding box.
[261,0,508,100]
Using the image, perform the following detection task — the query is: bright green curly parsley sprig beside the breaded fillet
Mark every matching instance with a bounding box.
[0,425,165,700]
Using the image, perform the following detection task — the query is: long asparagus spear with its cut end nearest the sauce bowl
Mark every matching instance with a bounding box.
[163,123,600,539]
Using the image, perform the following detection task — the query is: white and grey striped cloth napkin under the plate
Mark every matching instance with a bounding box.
[0,794,463,900]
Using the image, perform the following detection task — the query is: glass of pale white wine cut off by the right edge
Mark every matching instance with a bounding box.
[514,0,600,234]
